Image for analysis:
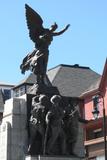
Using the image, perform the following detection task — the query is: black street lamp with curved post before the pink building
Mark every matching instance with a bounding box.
[92,94,107,160]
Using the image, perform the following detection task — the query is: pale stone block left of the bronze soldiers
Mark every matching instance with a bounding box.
[0,96,27,160]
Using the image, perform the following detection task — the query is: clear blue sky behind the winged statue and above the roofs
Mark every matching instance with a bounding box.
[0,0,107,84]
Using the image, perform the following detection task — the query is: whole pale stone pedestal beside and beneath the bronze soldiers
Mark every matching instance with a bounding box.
[0,90,84,160]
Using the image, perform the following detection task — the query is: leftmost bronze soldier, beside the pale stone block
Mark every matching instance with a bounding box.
[28,95,48,155]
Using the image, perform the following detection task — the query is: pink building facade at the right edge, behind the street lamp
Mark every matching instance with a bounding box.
[81,60,107,160]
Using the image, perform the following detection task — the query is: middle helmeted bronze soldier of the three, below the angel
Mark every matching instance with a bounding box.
[46,95,66,155]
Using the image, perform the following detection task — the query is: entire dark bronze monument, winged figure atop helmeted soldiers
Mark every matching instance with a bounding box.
[20,4,86,156]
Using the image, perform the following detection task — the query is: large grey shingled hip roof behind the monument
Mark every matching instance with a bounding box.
[47,64,101,97]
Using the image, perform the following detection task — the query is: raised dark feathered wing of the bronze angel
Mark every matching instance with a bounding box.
[25,4,45,43]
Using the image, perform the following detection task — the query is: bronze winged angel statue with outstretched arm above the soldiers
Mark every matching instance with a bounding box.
[20,4,70,84]
